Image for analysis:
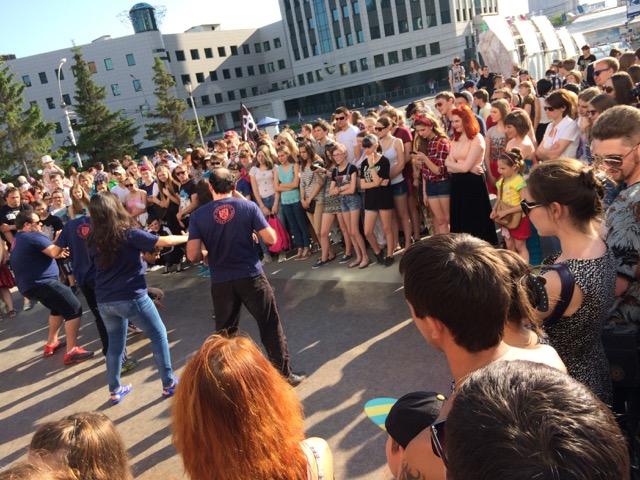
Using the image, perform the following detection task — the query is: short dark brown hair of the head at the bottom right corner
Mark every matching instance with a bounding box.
[444,360,630,480]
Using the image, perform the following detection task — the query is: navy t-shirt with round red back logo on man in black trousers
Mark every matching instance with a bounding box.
[189,198,269,283]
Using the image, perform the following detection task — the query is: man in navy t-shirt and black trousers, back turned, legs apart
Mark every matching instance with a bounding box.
[187,168,303,386]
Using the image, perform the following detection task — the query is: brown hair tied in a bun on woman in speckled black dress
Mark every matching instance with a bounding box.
[527,158,604,228]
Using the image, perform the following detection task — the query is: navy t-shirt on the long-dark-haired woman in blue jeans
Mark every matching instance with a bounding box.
[90,228,158,303]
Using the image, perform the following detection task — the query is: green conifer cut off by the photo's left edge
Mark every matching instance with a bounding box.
[0,61,54,174]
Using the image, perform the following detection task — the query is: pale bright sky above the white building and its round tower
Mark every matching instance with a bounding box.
[0,0,281,57]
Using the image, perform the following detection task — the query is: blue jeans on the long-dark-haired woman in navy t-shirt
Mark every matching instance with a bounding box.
[98,294,175,392]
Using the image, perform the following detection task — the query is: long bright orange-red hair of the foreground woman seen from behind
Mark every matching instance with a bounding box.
[172,335,307,480]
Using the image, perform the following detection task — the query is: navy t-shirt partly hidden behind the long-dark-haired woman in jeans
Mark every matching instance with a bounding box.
[56,215,96,284]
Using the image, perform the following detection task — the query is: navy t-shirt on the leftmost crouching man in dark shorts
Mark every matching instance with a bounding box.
[10,232,58,293]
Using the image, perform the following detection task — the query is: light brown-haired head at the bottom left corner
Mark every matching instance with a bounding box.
[29,412,133,480]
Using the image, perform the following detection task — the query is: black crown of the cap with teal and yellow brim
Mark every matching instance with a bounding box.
[384,392,446,448]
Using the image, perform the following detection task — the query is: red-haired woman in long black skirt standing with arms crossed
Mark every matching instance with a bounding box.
[445,105,498,245]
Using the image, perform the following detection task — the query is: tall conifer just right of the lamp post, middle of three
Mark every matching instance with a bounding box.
[72,48,141,163]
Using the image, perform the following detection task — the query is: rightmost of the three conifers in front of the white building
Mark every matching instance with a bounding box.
[145,57,213,148]
